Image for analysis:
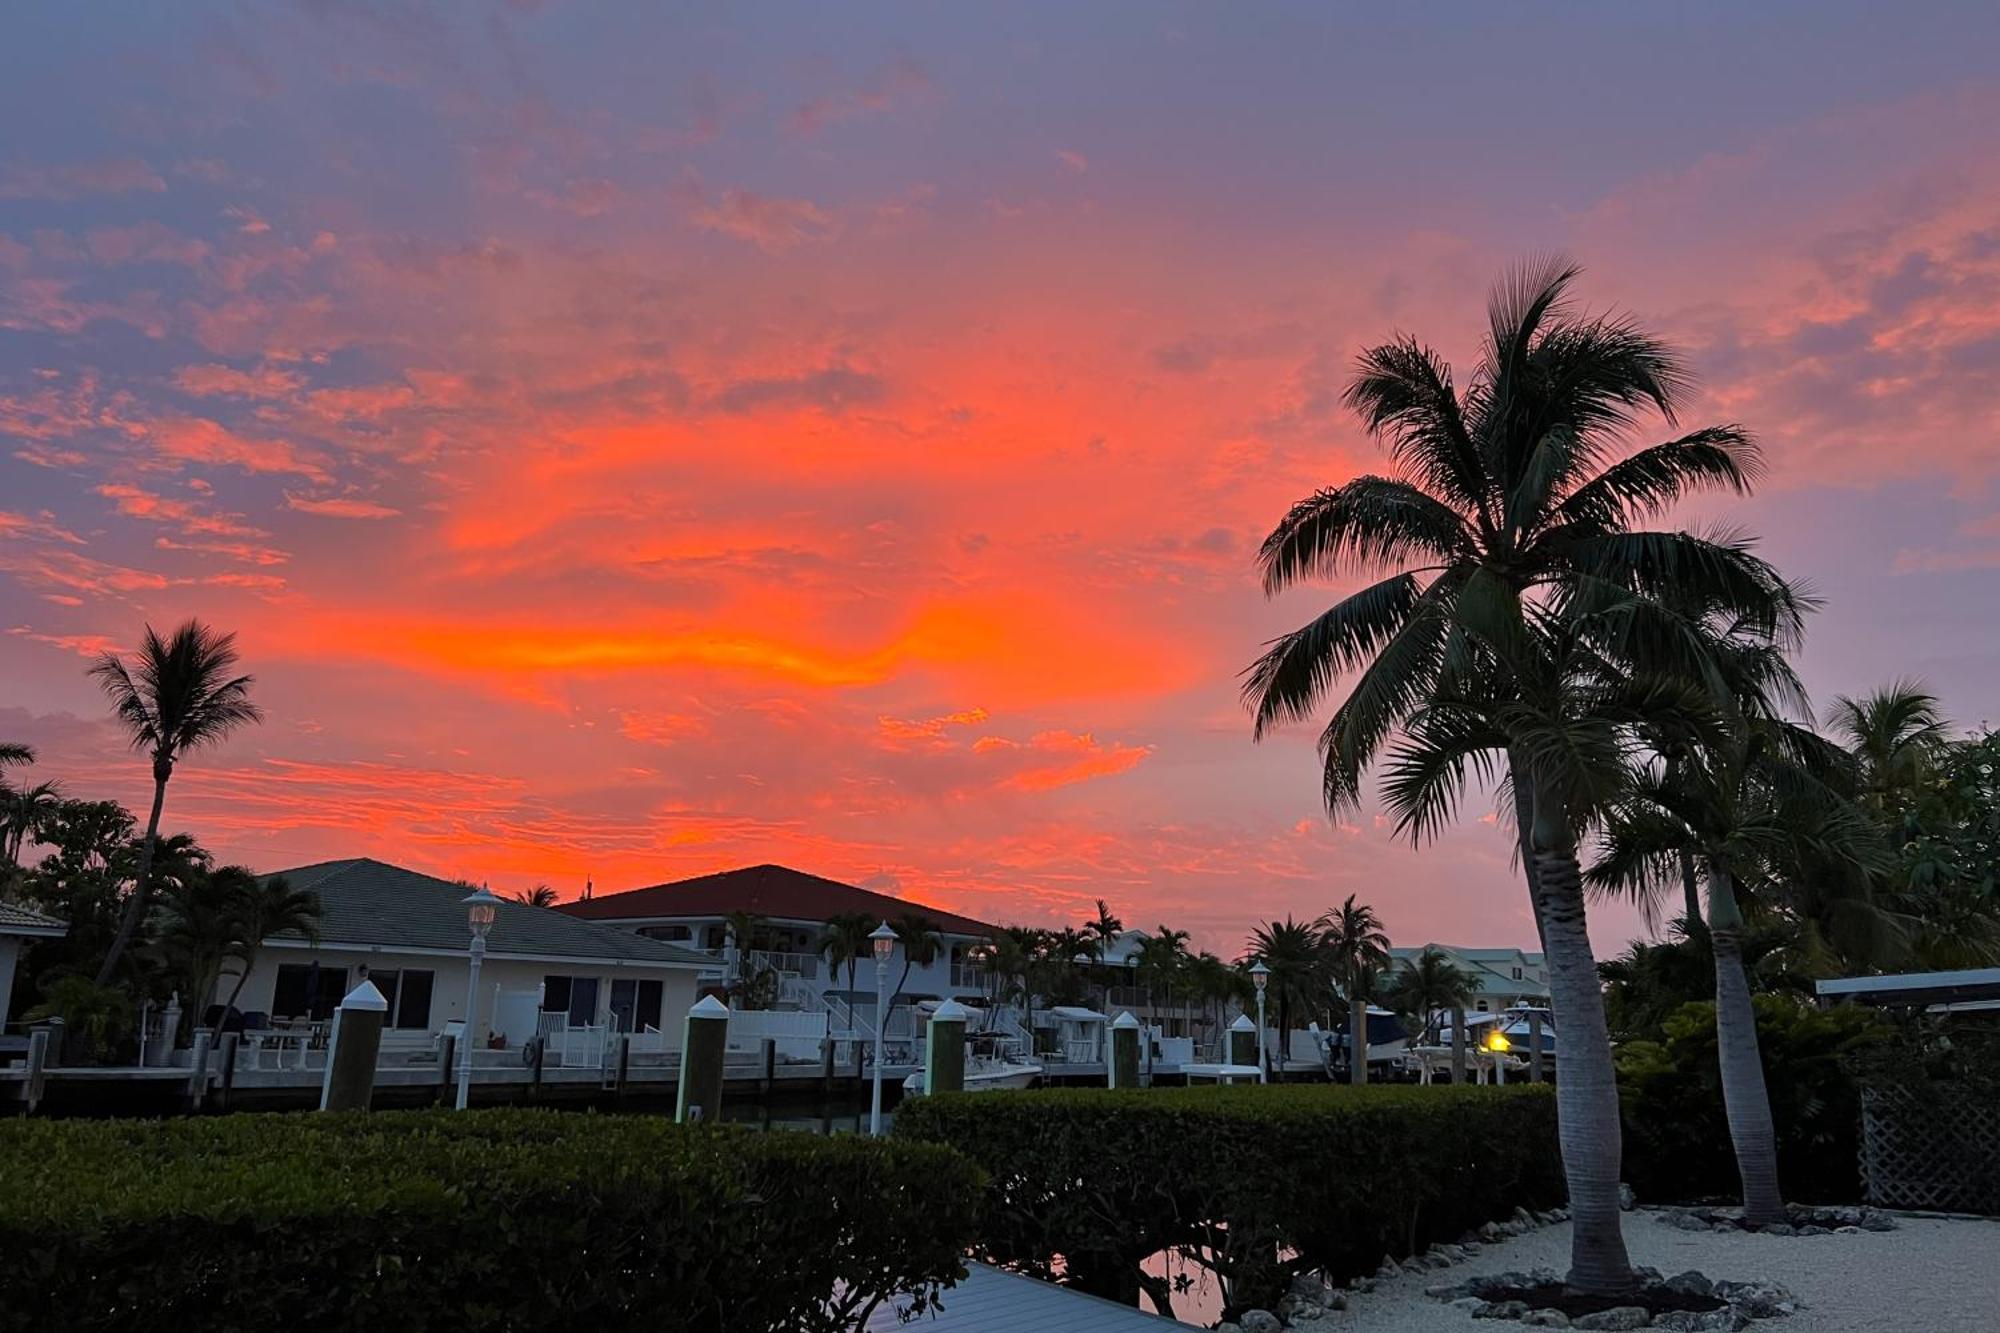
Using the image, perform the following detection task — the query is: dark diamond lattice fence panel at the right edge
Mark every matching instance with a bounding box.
[1862,1085,2000,1215]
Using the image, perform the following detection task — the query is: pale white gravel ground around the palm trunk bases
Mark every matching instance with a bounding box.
[1320,1209,2000,1333]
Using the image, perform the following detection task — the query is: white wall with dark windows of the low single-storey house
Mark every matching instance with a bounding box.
[229,947,696,1041]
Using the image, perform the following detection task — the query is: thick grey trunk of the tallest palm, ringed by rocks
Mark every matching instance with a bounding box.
[1534,836,1638,1295]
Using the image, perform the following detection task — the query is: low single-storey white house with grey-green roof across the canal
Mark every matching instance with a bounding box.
[222,857,712,1041]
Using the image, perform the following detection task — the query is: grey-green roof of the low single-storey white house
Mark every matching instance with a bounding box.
[264,857,714,967]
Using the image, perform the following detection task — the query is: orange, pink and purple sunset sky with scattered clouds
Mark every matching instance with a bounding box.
[0,0,2000,955]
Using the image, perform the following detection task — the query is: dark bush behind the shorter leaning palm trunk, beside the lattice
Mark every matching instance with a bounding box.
[1618,995,1888,1203]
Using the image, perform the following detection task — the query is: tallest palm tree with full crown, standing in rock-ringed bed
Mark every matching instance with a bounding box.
[1244,262,1802,1295]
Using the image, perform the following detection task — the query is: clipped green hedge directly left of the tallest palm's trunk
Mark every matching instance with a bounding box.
[896,1085,1566,1313]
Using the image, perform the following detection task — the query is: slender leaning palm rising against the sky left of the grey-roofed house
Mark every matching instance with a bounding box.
[90,620,264,987]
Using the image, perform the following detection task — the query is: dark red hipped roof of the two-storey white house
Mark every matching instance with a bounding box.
[556,865,998,935]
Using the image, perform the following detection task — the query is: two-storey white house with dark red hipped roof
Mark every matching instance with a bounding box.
[556,865,998,1027]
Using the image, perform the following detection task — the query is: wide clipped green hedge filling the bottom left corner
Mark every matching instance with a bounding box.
[0,1111,984,1333]
